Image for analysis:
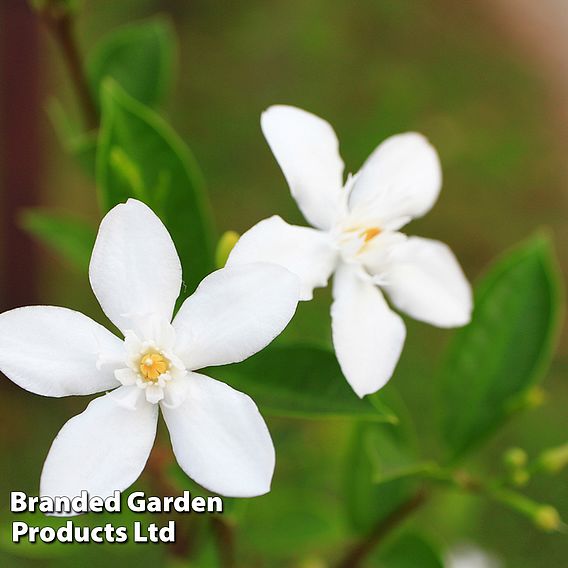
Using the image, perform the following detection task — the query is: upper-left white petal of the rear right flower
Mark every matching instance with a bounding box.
[261,105,344,229]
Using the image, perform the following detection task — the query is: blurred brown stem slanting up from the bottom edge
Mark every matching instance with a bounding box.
[337,489,427,568]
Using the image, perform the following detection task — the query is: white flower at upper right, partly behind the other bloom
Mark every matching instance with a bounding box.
[227,106,472,396]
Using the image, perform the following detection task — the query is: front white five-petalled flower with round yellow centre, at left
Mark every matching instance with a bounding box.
[0,200,299,497]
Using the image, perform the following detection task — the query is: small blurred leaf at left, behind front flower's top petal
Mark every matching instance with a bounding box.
[21,209,96,272]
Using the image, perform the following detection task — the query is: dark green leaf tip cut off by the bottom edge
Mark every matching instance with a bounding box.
[379,533,444,568]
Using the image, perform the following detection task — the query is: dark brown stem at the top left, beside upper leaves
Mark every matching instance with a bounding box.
[41,3,99,130]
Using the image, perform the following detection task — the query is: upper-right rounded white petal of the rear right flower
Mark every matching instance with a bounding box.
[349,132,442,230]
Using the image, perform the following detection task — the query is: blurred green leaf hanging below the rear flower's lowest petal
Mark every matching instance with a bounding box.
[344,387,417,533]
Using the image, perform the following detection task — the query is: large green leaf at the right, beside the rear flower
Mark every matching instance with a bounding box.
[441,235,562,459]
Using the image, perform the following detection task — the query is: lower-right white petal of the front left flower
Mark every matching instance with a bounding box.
[162,373,275,497]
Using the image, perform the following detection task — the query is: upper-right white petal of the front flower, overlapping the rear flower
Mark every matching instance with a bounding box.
[173,262,300,370]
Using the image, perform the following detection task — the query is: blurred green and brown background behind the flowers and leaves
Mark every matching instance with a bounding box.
[0,0,568,568]
